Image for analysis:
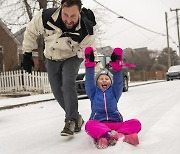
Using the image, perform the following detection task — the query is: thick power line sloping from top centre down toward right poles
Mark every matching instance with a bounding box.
[93,0,166,36]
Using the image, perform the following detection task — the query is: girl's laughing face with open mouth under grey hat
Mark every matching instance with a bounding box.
[97,74,111,91]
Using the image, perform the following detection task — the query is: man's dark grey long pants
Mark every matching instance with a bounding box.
[46,56,83,121]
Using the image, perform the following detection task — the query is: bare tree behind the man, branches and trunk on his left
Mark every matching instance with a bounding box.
[0,0,57,71]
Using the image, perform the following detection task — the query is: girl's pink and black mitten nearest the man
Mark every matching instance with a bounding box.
[84,47,96,67]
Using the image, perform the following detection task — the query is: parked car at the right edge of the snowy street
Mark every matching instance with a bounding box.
[166,65,180,81]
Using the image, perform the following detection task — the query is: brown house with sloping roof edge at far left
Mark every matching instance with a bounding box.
[0,19,19,72]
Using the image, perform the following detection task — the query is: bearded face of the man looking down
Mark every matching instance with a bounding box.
[61,5,80,29]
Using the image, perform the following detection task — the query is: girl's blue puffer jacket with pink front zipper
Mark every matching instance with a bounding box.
[85,68,123,122]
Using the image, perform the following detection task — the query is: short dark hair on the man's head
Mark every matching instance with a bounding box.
[61,0,82,10]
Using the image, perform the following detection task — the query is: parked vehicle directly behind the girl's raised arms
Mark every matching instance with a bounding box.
[76,54,129,95]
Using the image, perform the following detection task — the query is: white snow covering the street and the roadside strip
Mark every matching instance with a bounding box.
[0,80,180,154]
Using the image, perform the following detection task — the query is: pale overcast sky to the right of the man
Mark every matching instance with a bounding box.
[83,0,180,53]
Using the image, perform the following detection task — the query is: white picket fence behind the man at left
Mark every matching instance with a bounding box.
[0,70,51,93]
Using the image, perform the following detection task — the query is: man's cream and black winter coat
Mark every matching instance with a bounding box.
[23,8,96,60]
